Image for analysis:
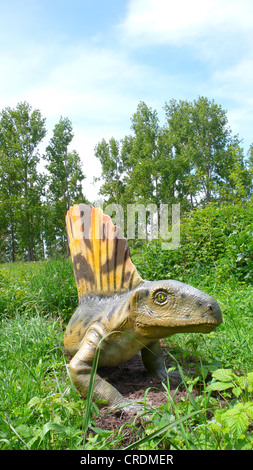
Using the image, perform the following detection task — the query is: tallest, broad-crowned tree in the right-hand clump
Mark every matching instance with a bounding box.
[165,97,233,207]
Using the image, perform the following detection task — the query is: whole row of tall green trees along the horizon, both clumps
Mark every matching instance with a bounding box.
[0,97,253,262]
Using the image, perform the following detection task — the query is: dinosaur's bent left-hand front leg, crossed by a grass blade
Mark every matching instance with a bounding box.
[69,323,143,411]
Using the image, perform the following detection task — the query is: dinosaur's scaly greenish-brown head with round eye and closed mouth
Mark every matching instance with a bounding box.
[130,280,222,339]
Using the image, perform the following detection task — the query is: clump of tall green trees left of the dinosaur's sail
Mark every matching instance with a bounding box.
[0,103,84,262]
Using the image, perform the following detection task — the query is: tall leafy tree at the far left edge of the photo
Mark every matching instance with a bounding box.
[0,102,46,261]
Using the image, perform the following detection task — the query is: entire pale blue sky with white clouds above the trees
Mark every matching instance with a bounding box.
[0,0,253,199]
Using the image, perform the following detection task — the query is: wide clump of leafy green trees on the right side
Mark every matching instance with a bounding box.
[95,97,252,212]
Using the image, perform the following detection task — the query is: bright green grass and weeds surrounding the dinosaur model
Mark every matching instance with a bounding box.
[0,261,253,450]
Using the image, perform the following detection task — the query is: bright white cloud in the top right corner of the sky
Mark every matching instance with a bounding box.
[122,0,253,44]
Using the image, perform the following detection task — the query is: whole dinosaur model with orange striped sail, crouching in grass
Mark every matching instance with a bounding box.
[64,204,222,409]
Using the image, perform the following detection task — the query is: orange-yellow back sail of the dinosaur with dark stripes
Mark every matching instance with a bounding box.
[66,204,142,299]
